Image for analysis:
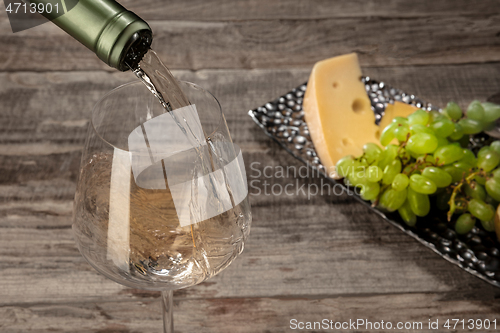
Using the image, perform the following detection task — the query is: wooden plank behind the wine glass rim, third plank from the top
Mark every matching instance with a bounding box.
[0,63,500,147]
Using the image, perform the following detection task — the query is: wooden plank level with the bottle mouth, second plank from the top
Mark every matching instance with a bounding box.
[0,14,500,71]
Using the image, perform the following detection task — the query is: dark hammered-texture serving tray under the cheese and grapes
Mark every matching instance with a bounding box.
[248,77,500,287]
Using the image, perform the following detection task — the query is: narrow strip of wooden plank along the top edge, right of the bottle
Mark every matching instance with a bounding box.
[120,0,498,21]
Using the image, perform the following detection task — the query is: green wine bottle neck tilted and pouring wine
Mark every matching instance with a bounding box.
[30,0,153,71]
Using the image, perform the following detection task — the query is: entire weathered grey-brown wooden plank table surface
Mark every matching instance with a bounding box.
[0,0,500,333]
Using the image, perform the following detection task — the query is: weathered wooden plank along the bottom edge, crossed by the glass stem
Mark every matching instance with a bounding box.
[0,293,500,333]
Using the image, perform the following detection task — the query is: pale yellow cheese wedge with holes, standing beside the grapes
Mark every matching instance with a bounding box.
[303,53,415,177]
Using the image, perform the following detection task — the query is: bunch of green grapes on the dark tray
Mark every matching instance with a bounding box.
[336,101,500,234]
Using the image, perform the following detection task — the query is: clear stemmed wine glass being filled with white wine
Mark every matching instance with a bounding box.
[73,81,251,332]
